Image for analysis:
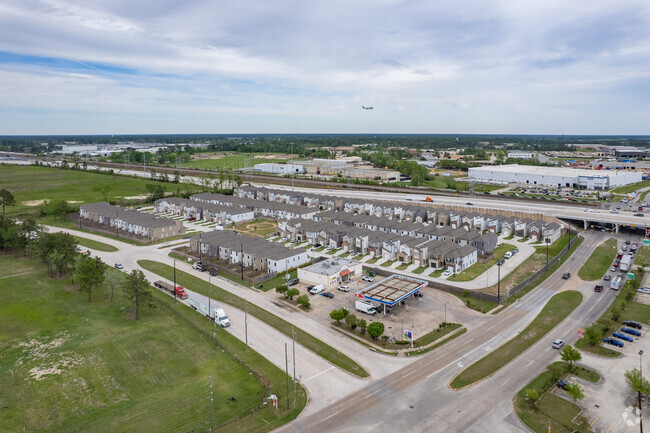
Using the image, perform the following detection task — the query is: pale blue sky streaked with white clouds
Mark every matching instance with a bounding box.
[0,0,650,135]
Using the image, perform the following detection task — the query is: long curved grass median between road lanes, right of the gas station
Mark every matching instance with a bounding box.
[450,290,582,389]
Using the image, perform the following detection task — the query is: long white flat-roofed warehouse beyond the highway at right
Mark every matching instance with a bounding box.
[469,164,643,190]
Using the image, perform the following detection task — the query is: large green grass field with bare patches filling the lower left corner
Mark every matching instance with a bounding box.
[0,256,306,432]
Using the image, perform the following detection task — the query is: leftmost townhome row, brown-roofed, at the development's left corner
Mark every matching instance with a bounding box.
[79,202,185,242]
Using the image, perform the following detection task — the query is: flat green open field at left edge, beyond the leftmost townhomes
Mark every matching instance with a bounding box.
[0,164,198,215]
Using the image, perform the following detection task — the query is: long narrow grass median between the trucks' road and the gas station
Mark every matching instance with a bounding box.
[138,260,368,377]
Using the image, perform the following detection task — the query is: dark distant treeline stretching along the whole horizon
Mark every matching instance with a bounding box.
[0,134,650,156]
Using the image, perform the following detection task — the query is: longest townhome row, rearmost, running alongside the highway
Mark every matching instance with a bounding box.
[235,186,562,242]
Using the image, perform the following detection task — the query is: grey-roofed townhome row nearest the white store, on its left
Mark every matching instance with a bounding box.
[189,230,310,274]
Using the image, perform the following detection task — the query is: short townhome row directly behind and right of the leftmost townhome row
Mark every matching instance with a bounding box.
[154,197,255,225]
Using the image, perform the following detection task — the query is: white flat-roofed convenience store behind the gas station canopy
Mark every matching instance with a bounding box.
[298,257,363,289]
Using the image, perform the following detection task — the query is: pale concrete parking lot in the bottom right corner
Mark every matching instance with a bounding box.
[554,323,650,433]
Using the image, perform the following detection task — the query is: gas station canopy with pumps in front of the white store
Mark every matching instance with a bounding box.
[355,274,427,315]
